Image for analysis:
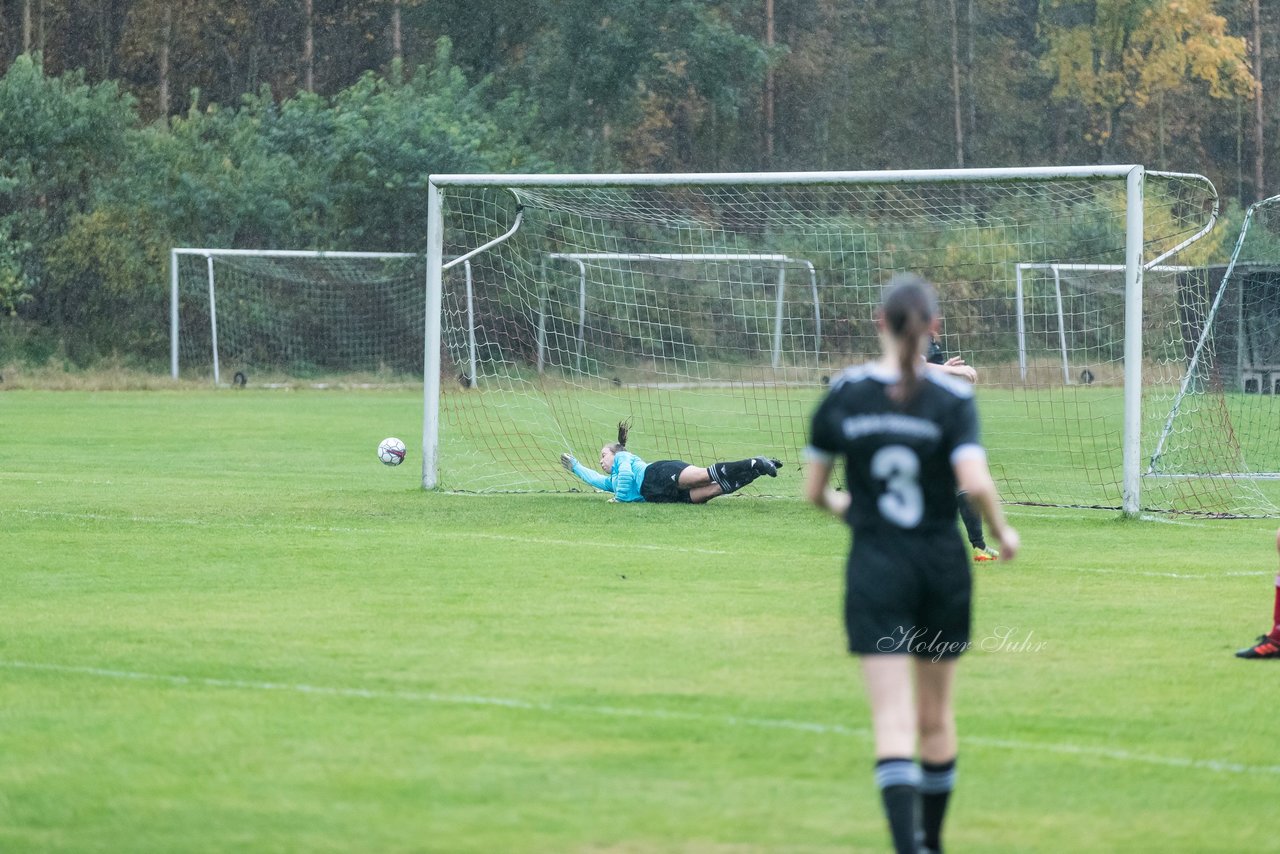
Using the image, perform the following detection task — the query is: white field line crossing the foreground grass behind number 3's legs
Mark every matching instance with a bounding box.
[0,659,1280,776]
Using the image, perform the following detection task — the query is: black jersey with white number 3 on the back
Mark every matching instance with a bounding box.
[809,364,983,531]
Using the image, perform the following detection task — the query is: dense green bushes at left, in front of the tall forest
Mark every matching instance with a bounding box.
[0,40,548,362]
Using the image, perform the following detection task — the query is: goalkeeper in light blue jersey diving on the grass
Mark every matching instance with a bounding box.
[561,421,782,504]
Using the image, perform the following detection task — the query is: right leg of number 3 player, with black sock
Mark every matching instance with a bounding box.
[915,658,957,851]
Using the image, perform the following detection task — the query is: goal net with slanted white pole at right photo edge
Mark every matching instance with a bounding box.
[1146,196,1280,516]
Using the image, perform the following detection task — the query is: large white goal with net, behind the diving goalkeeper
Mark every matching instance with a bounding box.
[424,166,1238,512]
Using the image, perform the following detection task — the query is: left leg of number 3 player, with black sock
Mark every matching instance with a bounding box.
[861,653,920,854]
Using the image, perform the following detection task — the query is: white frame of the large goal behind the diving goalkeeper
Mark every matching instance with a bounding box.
[422,164,1217,516]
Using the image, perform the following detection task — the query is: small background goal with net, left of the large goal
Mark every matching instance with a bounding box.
[170,248,425,385]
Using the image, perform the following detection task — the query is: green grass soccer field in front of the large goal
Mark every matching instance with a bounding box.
[0,391,1280,853]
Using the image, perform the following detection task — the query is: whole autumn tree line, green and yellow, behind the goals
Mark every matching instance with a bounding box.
[0,0,1280,362]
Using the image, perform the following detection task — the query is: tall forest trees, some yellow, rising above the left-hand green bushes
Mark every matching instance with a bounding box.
[0,0,1264,180]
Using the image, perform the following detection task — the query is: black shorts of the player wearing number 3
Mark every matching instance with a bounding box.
[845,529,973,659]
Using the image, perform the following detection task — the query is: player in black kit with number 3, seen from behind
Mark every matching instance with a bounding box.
[805,274,1019,854]
